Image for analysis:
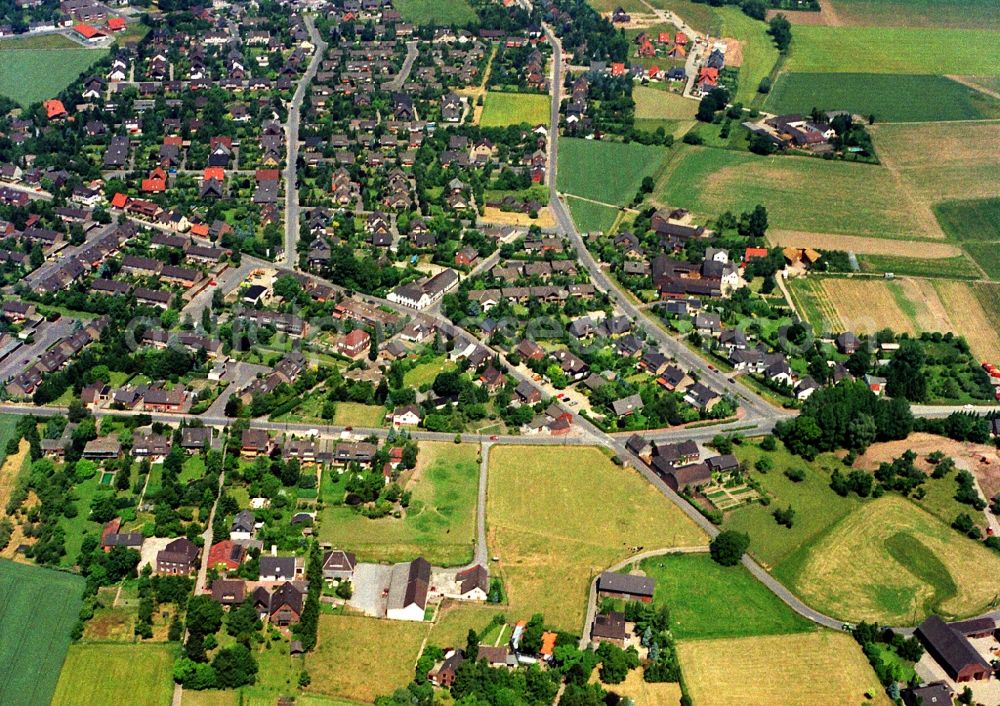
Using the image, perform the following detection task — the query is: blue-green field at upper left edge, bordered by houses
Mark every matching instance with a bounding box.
[0,37,108,106]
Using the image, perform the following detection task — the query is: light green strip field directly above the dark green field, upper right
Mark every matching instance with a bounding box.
[784,26,1000,76]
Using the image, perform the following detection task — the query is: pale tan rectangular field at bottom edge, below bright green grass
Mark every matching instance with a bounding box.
[677,631,890,706]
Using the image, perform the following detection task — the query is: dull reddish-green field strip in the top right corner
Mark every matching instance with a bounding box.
[834,0,1000,29]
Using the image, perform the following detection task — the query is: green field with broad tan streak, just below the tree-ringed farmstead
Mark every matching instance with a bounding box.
[655,145,942,239]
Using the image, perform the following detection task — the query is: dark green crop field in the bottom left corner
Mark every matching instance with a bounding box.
[0,559,83,706]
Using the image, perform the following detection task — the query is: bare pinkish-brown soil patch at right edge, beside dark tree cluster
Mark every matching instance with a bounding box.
[854,432,1000,497]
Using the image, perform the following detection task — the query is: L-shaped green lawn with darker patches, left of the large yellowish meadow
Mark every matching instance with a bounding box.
[319,441,479,565]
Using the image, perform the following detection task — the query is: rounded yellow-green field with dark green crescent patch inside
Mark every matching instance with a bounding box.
[780,496,1000,625]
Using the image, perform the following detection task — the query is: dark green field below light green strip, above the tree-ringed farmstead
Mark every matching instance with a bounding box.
[764,72,996,122]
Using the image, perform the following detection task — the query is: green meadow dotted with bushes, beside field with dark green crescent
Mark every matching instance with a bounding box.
[724,441,860,569]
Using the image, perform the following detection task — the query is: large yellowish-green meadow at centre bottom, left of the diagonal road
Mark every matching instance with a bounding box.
[486,446,707,631]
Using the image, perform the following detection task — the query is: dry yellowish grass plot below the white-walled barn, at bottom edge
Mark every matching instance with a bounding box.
[306,615,428,703]
